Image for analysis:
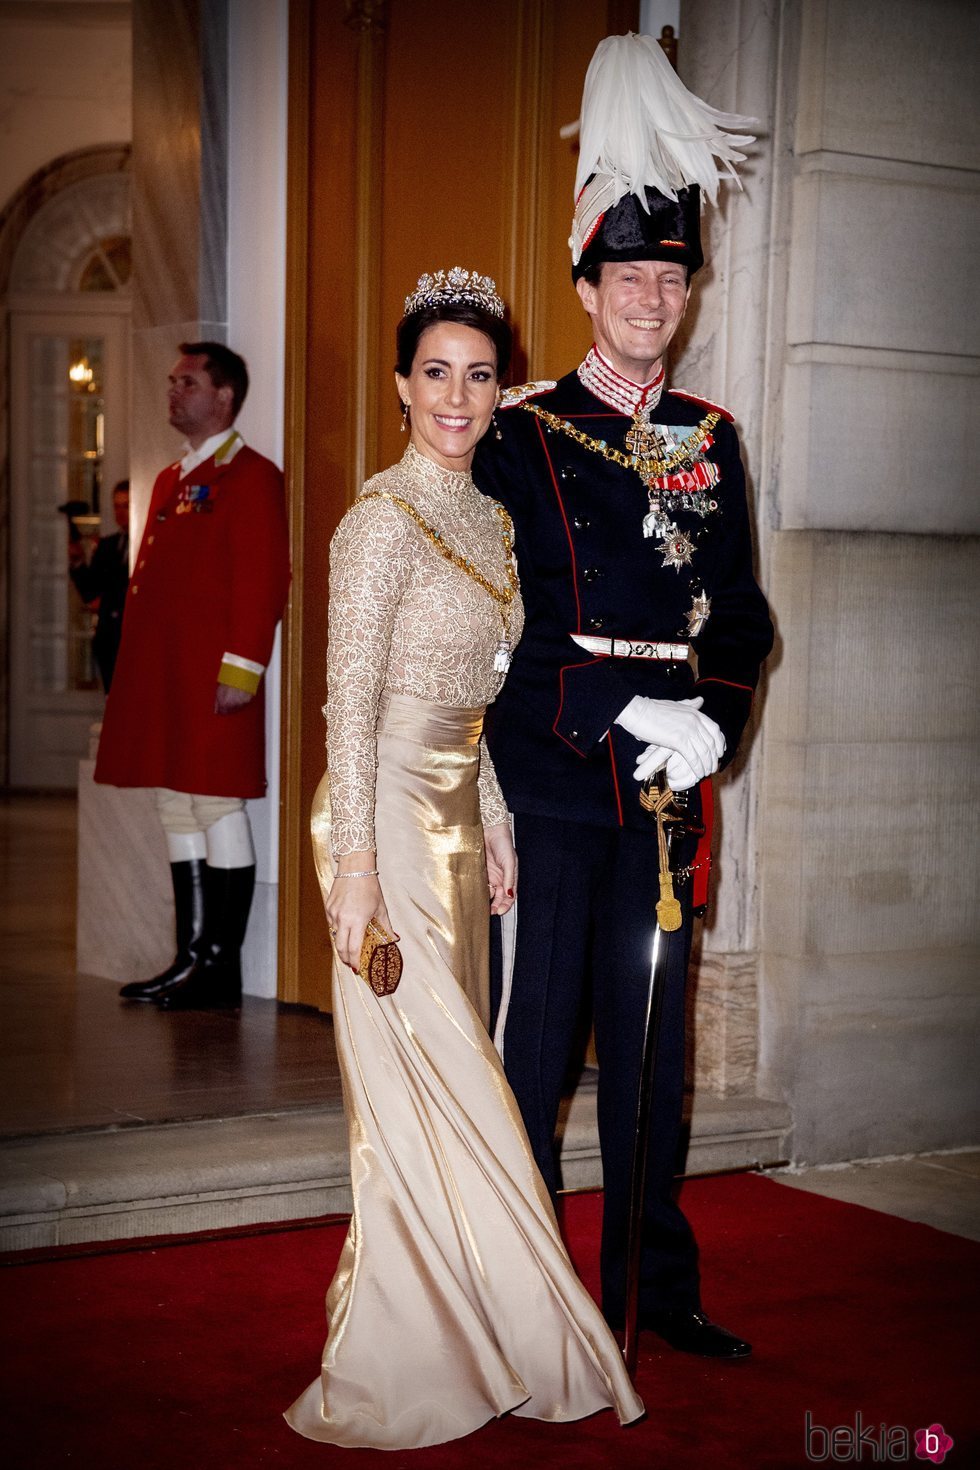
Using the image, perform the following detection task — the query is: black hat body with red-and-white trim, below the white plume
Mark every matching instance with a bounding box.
[572,175,704,281]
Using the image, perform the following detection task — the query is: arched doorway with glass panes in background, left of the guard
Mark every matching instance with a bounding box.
[7,165,131,789]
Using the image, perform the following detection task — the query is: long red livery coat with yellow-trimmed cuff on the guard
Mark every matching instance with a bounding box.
[96,445,289,797]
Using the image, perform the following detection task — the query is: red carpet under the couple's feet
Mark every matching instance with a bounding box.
[0,1175,980,1470]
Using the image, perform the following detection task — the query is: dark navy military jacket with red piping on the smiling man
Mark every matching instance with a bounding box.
[473,363,773,828]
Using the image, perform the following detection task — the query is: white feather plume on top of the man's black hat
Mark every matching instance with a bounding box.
[561,34,755,209]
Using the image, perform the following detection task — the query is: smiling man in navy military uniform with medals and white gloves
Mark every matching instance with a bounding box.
[475,37,773,1358]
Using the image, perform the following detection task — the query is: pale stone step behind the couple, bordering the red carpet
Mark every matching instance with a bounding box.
[0,1075,790,1251]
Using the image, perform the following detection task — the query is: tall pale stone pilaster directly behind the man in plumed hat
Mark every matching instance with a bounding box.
[671,0,779,1094]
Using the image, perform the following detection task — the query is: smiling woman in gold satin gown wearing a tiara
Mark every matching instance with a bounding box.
[287,268,644,1449]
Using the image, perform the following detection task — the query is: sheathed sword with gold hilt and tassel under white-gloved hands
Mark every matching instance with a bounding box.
[623,767,696,1374]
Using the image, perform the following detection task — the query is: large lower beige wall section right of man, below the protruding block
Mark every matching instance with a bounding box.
[760,534,980,1161]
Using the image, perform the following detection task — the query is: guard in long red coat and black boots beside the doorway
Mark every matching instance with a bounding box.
[96,343,289,1010]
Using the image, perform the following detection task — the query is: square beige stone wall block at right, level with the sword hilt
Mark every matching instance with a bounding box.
[761,739,980,964]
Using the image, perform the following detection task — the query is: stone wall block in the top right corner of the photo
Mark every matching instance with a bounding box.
[796,0,980,169]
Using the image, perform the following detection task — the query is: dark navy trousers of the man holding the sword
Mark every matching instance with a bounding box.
[492,814,699,1327]
